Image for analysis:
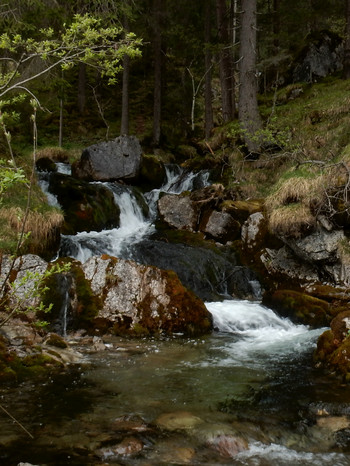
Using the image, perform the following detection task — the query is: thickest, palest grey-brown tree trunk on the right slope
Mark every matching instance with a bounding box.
[238,0,262,157]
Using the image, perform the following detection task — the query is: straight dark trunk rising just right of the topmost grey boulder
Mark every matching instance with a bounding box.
[153,0,163,147]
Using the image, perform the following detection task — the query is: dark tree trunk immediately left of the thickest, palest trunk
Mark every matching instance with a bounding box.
[216,0,233,123]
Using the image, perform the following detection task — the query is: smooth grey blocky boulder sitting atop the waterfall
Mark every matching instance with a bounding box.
[72,136,142,181]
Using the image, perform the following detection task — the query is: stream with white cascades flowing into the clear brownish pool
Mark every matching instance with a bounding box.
[0,168,350,466]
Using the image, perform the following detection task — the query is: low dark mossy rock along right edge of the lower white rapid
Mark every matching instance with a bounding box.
[263,290,331,328]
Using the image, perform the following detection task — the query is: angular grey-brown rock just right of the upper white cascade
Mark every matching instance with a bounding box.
[158,194,199,231]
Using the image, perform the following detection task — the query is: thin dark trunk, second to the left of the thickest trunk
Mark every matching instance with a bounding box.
[204,0,214,139]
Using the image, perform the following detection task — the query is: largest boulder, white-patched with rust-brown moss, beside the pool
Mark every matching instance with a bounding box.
[82,256,212,335]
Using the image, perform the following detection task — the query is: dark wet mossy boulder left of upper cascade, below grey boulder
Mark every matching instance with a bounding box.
[49,173,120,235]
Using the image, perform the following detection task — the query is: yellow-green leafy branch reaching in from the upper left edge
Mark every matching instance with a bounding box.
[0,14,141,99]
